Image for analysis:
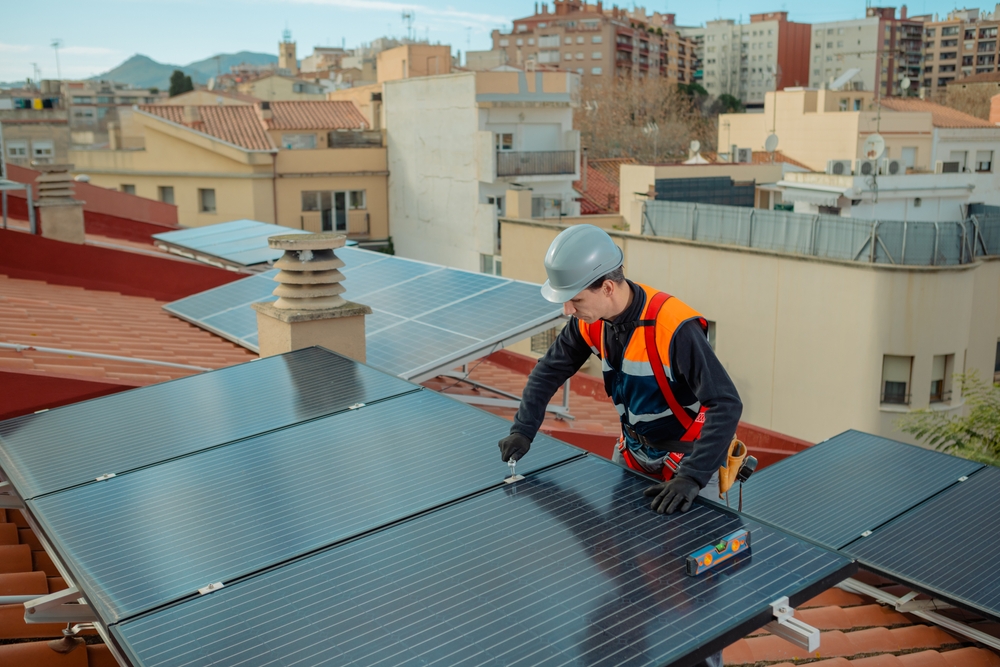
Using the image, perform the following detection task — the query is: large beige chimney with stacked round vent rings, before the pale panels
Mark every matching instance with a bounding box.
[253,232,372,362]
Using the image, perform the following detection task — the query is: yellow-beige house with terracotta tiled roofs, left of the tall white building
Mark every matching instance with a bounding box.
[70,101,389,241]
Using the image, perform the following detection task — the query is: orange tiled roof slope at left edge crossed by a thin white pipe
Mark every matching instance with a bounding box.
[0,275,256,386]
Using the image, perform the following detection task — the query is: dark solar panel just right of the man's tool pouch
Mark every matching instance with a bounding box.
[743,431,983,549]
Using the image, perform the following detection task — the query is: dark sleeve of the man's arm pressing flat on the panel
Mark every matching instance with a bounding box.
[670,321,743,487]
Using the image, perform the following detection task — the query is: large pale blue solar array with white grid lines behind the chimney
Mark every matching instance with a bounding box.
[164,248,562,382]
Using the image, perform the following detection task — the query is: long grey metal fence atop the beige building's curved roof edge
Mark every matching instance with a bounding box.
[642,201,1000,266]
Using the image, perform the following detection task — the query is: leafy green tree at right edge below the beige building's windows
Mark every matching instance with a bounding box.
[898,371,1000,465]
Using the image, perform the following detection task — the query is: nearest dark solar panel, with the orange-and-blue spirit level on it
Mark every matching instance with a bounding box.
[112,456,853,667]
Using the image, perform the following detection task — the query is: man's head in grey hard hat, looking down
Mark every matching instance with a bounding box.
[542,225,627,323]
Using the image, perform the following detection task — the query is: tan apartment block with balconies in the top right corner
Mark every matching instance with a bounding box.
[920,9,1000,100]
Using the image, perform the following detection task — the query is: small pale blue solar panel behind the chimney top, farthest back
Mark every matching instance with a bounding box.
[153,220,308,268]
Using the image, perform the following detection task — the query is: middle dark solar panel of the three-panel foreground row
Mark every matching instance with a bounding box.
[30,390,582,623]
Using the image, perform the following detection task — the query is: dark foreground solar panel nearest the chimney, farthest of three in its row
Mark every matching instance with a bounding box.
[0,348,414,499]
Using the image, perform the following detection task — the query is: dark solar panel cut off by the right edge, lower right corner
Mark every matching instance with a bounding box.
[843,466,1000,619]
